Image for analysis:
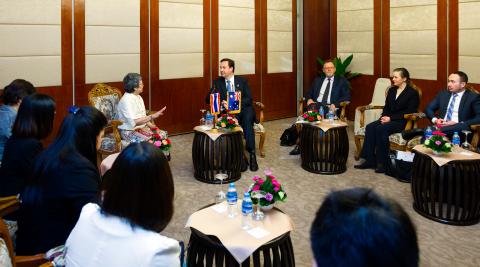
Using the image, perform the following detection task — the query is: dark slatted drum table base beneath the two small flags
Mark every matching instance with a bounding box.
[192,130,243,184]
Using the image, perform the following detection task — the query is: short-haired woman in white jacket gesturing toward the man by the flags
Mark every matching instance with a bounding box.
[117,73,167,143]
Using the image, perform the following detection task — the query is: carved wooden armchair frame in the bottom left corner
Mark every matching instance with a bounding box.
[0,196,53,267]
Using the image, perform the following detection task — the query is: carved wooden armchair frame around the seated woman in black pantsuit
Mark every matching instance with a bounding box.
[354,84,425,160]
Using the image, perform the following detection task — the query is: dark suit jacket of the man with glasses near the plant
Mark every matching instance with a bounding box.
[305,76,350,107]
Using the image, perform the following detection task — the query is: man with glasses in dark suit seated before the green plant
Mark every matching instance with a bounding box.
[290,60,350,155]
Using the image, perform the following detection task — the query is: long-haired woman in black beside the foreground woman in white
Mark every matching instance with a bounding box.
[17,107,107,255]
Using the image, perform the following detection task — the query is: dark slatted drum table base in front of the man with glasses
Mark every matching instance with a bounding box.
[300,123,348,174]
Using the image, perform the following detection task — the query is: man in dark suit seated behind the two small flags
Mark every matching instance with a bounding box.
[205,58,258,171]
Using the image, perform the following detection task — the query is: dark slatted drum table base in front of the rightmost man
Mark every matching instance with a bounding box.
[412,151,480,225]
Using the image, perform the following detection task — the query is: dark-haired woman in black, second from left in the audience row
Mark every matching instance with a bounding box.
[0,94,55,197]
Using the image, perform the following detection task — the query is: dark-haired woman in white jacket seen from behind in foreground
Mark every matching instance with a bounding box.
[66,142,180,267]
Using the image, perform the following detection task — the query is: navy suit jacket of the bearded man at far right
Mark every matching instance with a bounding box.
[425,90,480,126]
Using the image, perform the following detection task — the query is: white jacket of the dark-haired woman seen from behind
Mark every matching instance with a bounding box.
[65,203,180,267]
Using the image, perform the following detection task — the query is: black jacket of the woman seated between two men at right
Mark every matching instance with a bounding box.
[382,85,420,121]
